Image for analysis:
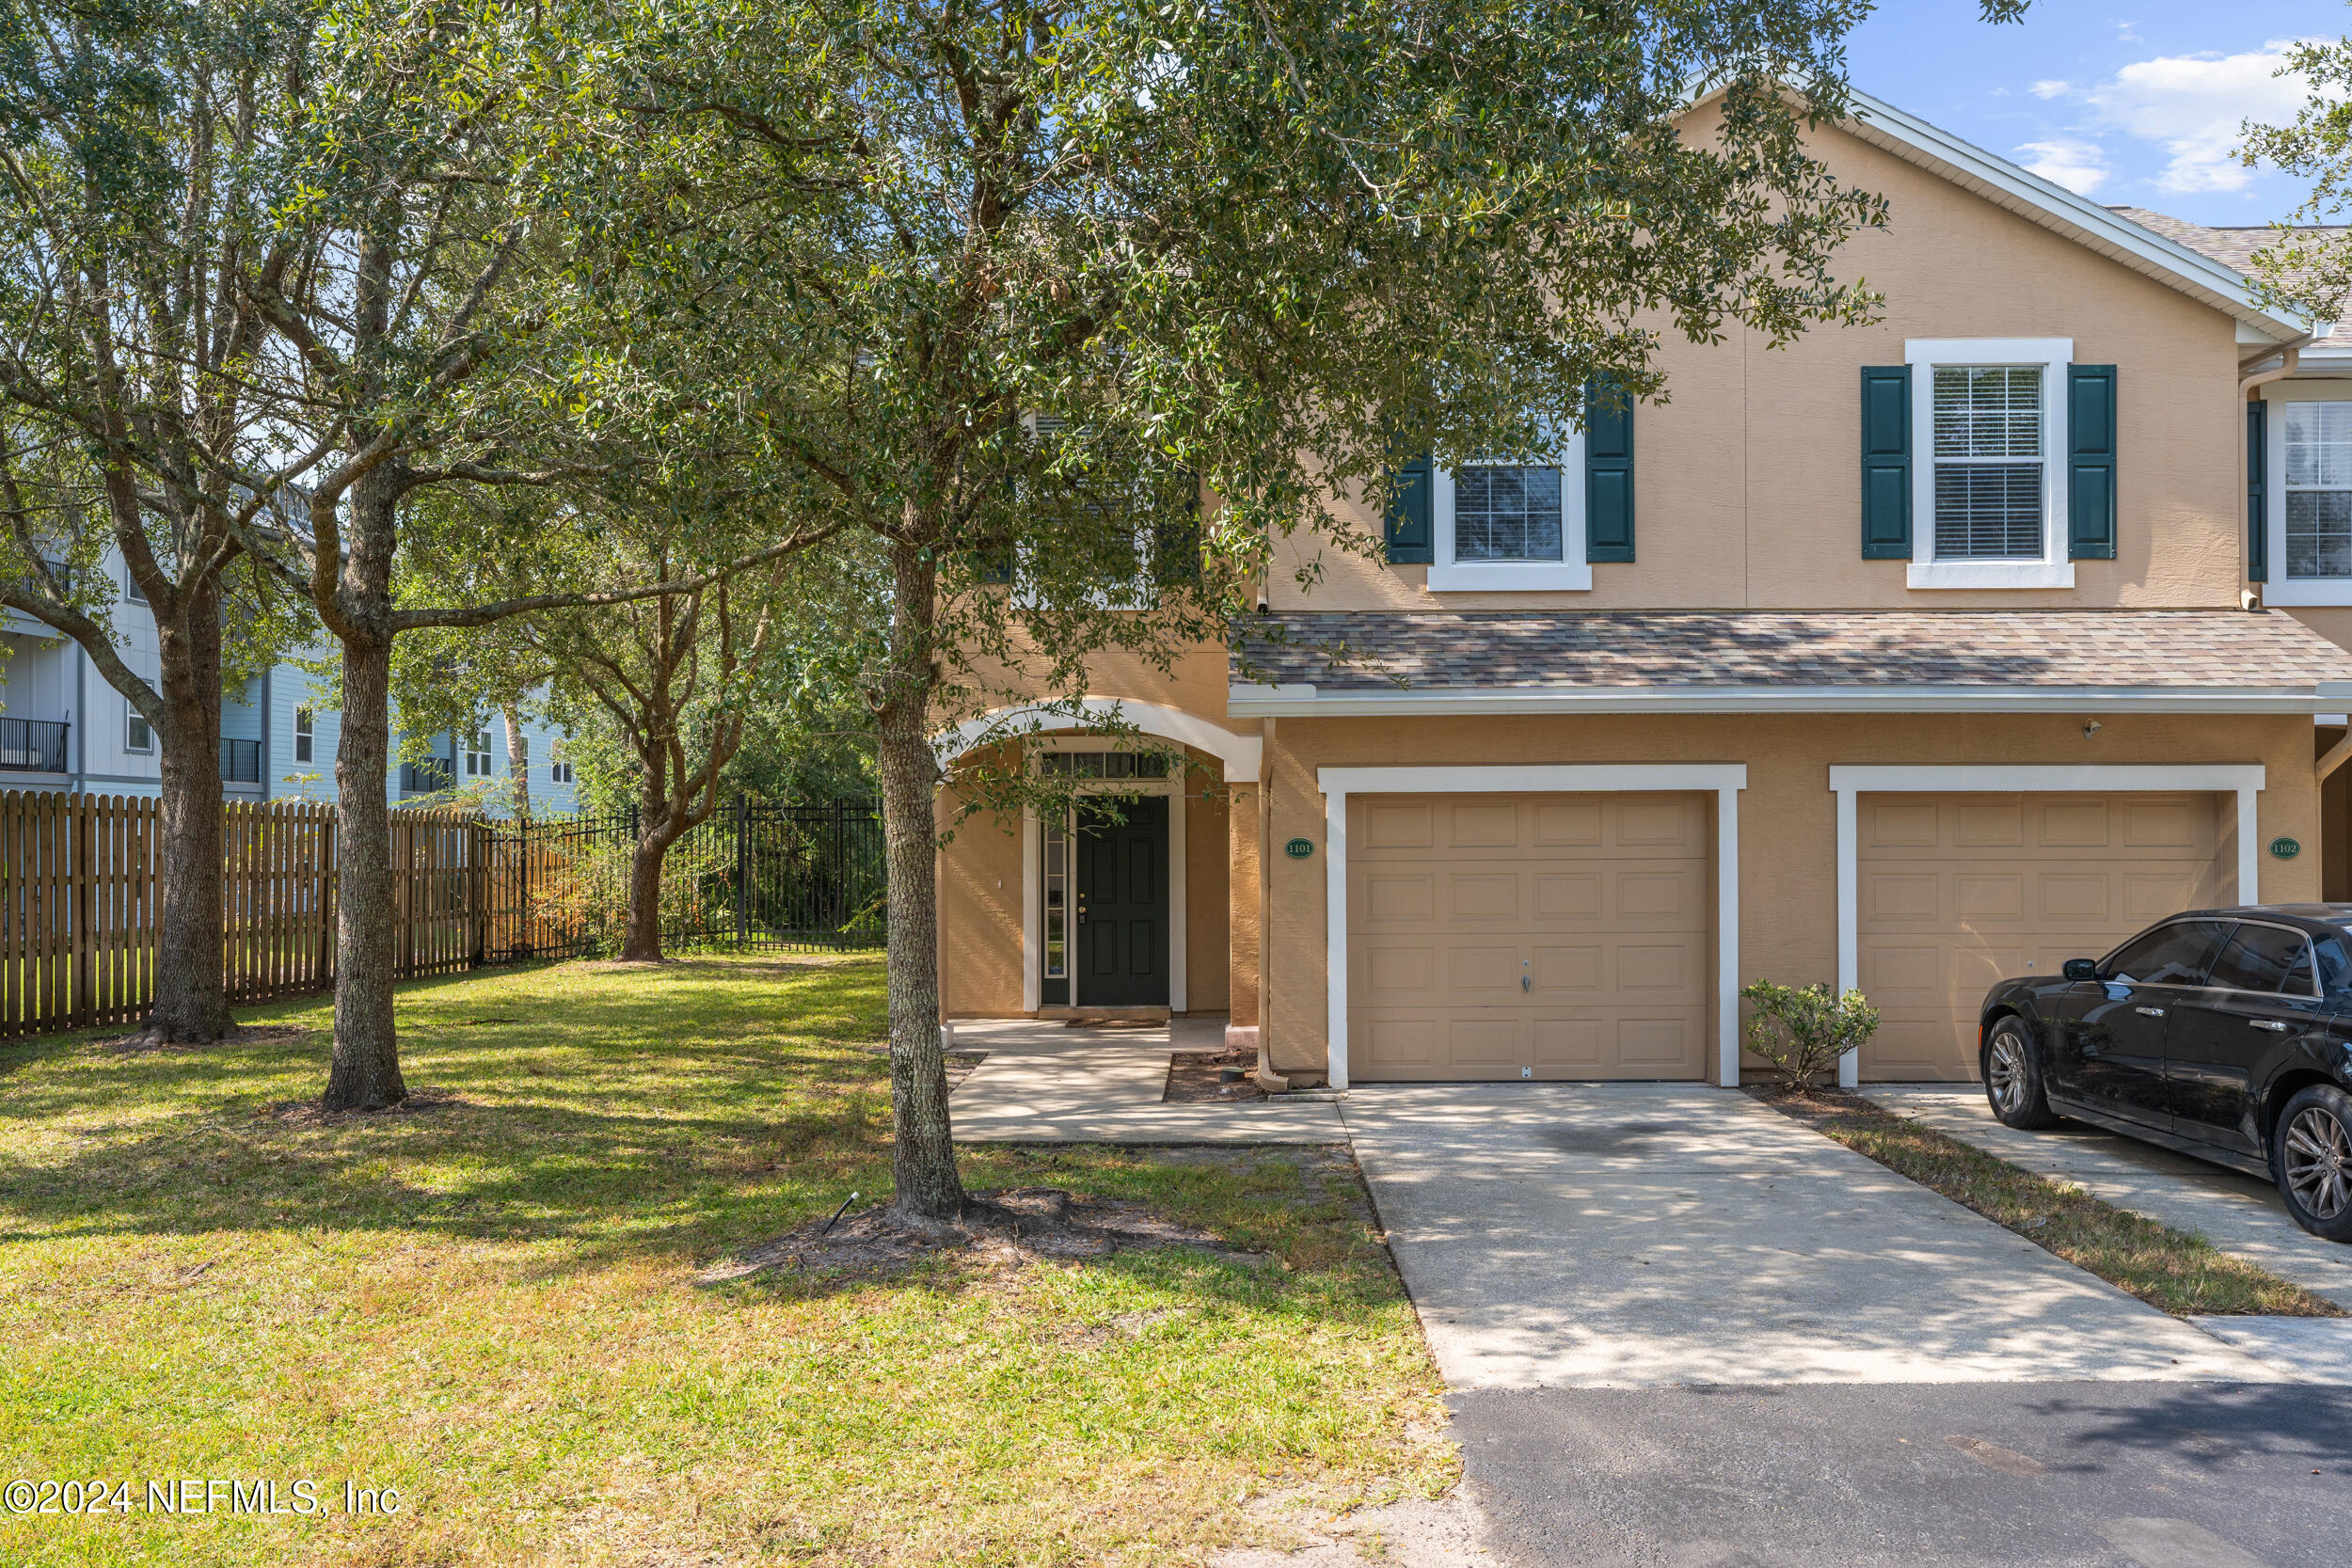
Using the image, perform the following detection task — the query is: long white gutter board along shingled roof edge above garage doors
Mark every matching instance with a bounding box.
[1226,682,2352,719]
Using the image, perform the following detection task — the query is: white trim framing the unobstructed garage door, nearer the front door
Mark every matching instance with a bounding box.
[1315,762,1748,1088]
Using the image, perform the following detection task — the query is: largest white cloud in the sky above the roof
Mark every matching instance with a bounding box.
[2089,40,2310,195]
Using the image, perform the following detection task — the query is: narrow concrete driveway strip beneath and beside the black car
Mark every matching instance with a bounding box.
[1863,1084,2352,1309]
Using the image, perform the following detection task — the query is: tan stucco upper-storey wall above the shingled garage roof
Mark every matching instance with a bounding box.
[1270,115,2247,609]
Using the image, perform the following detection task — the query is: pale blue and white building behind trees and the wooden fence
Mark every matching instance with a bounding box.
[0,550,577,811]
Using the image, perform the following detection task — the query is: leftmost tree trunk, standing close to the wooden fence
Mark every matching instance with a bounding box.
[144,583,235,1044]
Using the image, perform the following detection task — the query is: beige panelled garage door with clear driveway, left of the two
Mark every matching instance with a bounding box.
[1348,795,1715,1079]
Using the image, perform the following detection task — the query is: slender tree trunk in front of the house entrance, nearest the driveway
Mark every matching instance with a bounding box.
[875,546,969,1223]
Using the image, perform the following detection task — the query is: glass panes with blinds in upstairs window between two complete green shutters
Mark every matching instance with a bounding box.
[1933,364,2044,560]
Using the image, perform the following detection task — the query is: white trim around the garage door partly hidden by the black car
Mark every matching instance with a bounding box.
[1830,762,2265,1088]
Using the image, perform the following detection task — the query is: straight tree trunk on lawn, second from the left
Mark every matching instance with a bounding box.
[327,463,409,1110]
